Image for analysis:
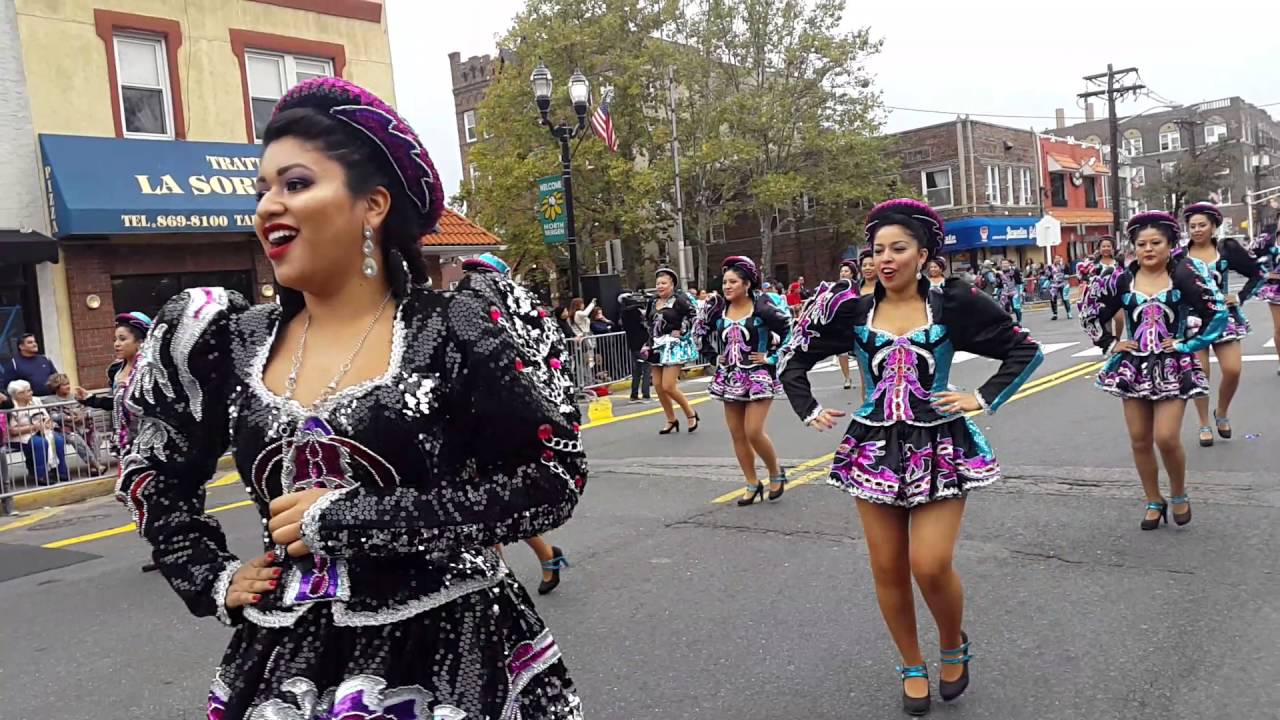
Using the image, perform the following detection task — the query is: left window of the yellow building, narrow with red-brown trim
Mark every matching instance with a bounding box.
[114,33,173,140]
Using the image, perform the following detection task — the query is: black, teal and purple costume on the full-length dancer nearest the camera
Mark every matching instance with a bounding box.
[781,278,1043,509]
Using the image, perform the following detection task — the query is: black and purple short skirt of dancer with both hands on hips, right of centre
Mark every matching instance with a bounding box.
[827,418,1000,509]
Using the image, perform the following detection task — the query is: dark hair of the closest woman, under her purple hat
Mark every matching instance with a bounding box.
[262,108,429,315]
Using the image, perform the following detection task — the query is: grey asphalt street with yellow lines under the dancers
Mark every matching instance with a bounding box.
[0,304,1280,720]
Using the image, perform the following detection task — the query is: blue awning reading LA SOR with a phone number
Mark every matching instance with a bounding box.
[40,135,262,237]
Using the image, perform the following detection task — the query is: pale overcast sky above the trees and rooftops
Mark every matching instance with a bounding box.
[387,0,1280,195]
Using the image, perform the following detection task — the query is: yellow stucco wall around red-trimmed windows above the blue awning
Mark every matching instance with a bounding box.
[15,0,396,142]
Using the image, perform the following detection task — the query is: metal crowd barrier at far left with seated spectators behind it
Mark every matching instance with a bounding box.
[0,397,116,505]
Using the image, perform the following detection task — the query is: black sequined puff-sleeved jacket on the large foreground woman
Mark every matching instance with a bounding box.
[116,274,586,626]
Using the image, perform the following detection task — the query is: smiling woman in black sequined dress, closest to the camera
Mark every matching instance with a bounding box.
[118,78,586,720]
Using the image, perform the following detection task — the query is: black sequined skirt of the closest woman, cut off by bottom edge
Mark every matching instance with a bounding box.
[206,574,582,720]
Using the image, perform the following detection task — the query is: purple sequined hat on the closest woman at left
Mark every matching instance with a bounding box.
[274,77,444,232]
